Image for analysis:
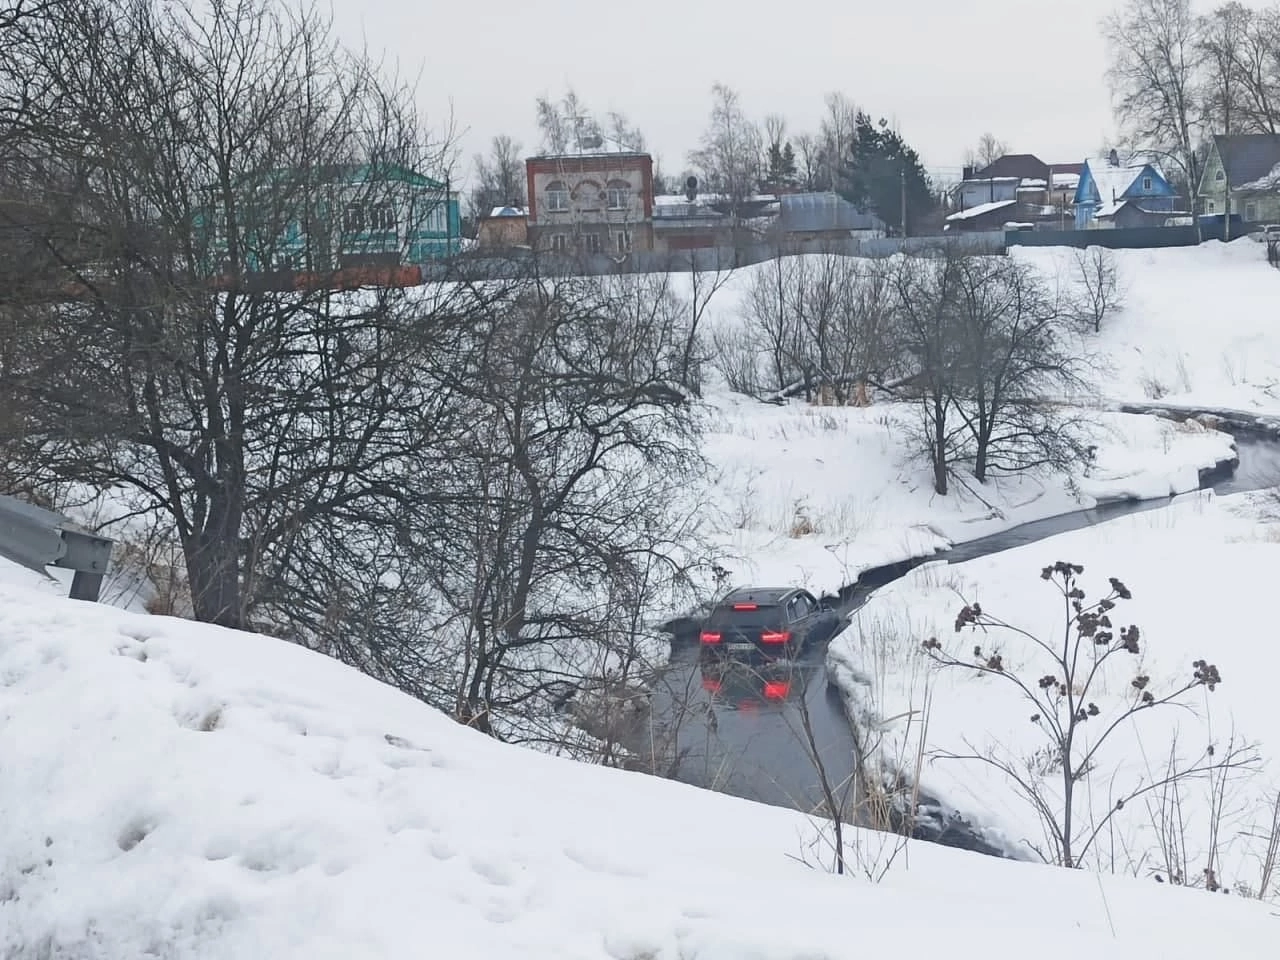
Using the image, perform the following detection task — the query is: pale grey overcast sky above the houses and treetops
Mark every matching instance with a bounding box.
[332,0,1218,188]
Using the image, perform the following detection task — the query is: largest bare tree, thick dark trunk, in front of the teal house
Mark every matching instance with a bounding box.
[2,0,462,632]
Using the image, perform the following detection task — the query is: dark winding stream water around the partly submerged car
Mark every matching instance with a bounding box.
[652,440,1280,852]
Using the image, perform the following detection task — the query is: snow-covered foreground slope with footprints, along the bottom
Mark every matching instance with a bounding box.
[0,576,1276,960]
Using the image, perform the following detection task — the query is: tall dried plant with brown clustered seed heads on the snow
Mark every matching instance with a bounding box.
[924,562,1258,868]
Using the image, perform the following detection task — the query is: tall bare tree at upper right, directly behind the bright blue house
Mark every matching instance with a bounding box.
[1102,0,1204,196]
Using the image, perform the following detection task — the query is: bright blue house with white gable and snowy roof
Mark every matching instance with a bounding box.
[1075,150,1180,230]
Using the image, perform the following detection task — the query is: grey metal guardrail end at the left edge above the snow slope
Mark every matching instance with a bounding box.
[0,495,115,602]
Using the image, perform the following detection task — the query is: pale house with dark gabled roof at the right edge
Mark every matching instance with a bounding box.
[1197,133,1280,223]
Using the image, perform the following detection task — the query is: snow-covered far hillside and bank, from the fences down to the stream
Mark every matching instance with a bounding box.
[676,239,1280,601]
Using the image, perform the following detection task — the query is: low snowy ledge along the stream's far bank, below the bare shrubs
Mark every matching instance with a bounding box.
[695,392,1234,593]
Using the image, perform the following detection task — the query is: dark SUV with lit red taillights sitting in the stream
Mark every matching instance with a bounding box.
[699,586,840,660]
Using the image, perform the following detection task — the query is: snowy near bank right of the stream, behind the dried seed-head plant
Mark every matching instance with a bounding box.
[828,493,1280,896]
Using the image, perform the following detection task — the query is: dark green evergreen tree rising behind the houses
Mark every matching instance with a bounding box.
[836,111,937,233]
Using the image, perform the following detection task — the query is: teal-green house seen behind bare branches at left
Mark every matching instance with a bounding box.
[196,164,461,273]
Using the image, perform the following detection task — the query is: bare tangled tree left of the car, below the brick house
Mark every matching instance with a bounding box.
[412,267,699,739]
